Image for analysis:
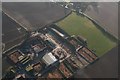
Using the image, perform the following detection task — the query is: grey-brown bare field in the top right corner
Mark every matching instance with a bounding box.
[85,2,118,38]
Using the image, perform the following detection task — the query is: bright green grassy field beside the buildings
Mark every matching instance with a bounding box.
[57,13,116,56]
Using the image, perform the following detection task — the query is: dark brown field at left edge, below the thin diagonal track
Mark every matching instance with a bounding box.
[2,13,26,51]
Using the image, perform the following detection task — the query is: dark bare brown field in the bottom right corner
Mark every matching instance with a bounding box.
[75,46,119,78]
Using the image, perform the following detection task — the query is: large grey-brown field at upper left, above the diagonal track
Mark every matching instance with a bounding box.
[2,2,71,31]
